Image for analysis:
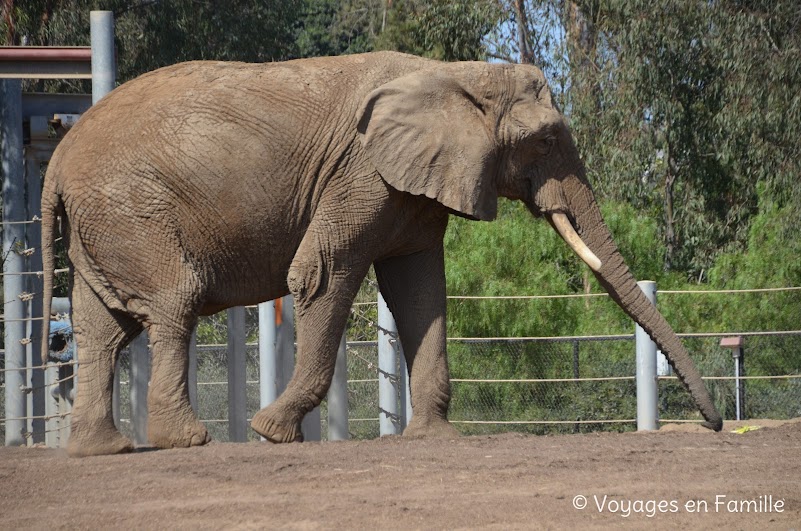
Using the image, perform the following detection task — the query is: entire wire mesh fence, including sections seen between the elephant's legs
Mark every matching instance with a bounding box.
[0,280,801,441]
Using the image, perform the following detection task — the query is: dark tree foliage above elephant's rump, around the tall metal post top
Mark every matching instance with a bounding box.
[0,0,304,87]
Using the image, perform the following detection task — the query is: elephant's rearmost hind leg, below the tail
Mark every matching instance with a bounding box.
[68,273,142,456]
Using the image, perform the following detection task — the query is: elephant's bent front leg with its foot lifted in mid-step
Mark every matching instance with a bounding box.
[251,222,370,443]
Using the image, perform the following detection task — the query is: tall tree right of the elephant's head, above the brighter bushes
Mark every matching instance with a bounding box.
[571,0,801,280]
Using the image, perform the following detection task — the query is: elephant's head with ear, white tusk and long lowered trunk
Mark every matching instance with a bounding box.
[358,59,722,430]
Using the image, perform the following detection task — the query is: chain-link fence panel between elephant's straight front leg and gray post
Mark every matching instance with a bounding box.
[448,336,636,434]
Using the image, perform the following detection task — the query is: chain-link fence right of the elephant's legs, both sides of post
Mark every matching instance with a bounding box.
[448,333,801,434]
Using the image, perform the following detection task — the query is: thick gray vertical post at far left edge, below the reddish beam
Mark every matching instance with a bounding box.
[0,79,26,446]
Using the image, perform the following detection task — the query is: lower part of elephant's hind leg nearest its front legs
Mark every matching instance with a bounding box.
[147,321,211,448]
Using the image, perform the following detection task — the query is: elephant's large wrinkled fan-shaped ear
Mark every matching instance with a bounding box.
[358,70,498,221]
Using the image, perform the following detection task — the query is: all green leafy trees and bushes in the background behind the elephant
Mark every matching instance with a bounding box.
[0,0,801,358]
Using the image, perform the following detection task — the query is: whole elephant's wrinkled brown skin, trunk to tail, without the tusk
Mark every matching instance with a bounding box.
[42,53,721,455]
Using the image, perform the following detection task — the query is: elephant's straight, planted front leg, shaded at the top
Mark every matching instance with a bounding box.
[375,243,458,437]
